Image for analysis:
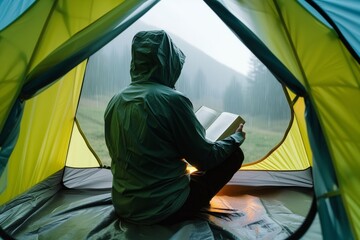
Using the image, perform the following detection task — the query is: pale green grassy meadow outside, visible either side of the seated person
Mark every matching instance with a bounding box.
[77,104,288,166]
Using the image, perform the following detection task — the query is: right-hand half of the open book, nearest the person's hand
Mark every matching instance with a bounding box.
[206,112,245,141]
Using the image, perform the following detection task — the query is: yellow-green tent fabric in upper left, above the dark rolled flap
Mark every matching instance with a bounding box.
[0,0,126,131]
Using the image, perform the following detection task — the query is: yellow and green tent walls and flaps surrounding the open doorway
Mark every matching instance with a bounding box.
[0,0,360,239]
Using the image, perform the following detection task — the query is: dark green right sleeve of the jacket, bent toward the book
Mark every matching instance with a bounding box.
[171,95,244,171]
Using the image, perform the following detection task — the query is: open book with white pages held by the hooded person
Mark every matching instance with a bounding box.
[195,106,245,141]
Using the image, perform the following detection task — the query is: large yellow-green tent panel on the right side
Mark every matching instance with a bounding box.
[212,0,360,236]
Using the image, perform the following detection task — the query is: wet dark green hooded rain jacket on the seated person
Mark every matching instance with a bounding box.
[105,31,244,224]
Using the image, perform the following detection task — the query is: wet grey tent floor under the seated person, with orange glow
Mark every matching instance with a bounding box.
[5,183,321,239]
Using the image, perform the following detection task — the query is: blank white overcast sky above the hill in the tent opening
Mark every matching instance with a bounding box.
[142,0,251,74]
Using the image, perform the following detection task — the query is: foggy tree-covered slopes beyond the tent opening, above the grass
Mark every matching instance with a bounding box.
[82,20,289,122]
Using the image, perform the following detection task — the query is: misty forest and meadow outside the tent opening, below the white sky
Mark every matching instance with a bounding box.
[77,21,291,166]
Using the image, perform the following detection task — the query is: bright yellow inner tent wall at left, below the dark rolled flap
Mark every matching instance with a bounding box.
[0,62,86,204]
